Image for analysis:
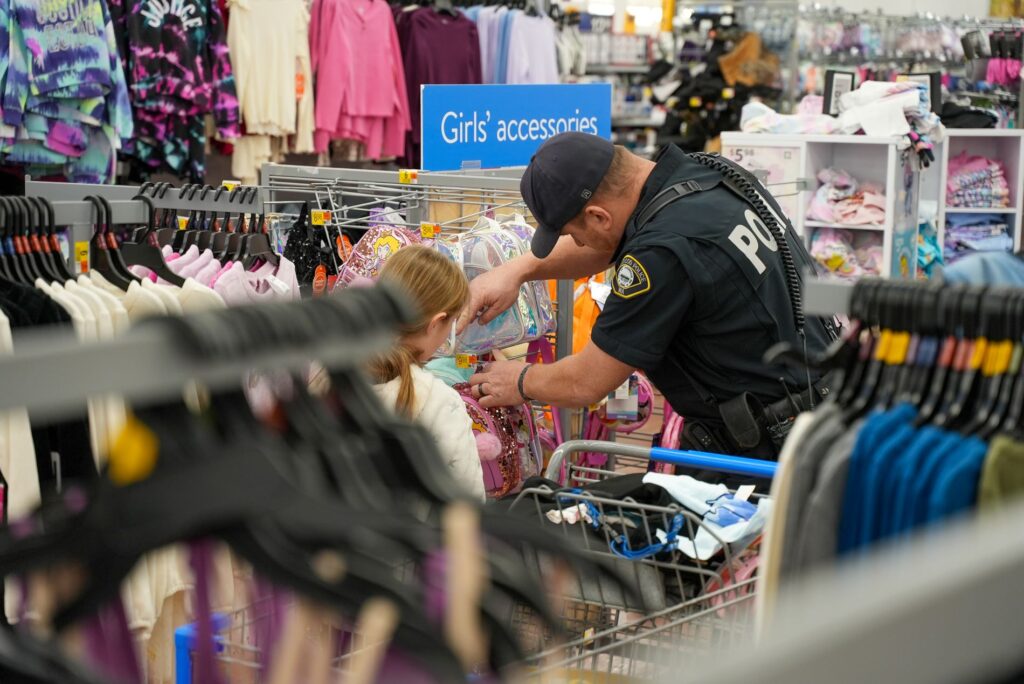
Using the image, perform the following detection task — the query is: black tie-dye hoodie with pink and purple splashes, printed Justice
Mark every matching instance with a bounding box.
[110,0,240,138]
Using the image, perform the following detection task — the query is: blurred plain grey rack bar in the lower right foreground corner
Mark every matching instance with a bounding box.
[674,493,1024,684]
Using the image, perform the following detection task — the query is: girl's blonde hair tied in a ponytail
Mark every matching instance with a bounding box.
[368,245,469,417]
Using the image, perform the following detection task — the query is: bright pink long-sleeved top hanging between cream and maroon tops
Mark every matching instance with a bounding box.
[309,0,412,159]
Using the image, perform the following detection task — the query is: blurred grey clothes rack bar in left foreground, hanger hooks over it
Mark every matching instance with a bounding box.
[0,288,408,417]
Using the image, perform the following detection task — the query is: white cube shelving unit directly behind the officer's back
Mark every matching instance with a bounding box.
[722,133,921,277]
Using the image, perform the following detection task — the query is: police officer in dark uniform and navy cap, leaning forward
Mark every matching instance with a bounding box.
[461,133,835,458]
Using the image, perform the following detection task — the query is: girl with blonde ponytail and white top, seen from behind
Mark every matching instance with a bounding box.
[369,246,486,501]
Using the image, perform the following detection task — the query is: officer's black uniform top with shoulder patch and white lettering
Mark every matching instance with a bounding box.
[592,146,827,421]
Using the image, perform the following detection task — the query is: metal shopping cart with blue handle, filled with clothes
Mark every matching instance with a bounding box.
[512,440,775,683]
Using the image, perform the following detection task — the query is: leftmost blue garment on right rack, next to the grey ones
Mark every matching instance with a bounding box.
[837,403,916,556]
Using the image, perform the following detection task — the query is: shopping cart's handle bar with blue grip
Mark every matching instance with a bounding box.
[544,439,778,480]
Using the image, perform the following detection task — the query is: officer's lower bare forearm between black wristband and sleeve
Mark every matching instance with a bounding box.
[523,342,634,409]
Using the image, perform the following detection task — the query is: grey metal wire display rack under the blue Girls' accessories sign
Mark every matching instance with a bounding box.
[260,164,574,435]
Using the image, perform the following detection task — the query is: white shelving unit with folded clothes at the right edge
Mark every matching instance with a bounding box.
[922,128,1024,259]
